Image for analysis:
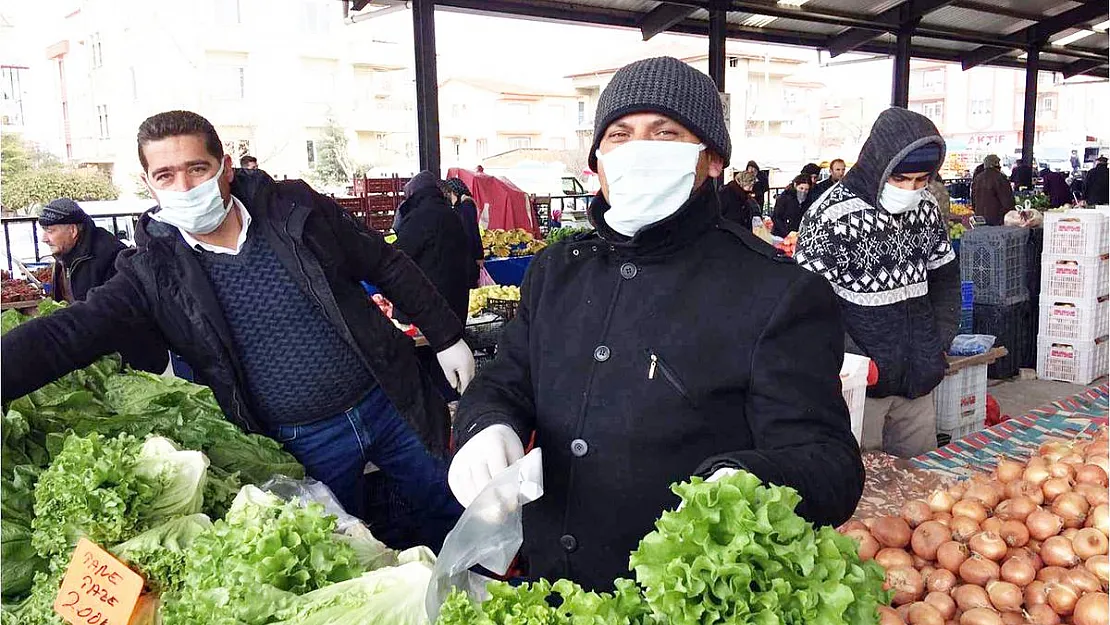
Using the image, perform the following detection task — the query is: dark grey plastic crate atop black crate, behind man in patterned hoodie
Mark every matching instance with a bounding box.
[960,225,1029,305]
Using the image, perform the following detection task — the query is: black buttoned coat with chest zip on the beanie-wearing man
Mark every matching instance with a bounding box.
[455,183,864,588]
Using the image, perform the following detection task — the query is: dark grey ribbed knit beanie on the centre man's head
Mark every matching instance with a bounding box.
[589,57,733,171]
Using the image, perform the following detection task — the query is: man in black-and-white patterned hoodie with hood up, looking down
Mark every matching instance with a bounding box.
[795,108,960,457]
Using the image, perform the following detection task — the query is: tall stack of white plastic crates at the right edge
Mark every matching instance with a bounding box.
[1037,209,1110,384]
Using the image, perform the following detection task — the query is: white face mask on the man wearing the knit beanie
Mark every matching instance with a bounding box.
[597,141,705,236]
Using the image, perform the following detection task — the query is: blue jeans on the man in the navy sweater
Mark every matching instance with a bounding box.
[274,387,463,552]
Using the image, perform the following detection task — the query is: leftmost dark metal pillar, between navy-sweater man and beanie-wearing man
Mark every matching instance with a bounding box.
[412,0,442,177]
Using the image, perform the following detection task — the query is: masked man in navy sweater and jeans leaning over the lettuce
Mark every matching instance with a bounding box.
[2,111,474,548]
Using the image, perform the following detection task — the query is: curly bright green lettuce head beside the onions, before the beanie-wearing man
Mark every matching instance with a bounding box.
[630,471,889,625]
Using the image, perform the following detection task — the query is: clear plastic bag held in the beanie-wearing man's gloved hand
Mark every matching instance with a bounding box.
[425,447,544,623]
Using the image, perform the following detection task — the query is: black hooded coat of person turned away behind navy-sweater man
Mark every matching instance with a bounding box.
[394,174,476,322]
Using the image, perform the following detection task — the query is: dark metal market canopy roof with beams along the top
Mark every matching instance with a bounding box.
[435,0,1110,78]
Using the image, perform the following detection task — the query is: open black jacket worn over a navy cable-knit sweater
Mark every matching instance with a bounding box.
[0,177,463,455]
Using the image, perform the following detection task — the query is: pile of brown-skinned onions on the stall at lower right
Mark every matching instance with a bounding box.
[840,429,1110,625]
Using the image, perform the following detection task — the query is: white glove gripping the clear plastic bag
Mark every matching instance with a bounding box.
[447,423,524,507]
